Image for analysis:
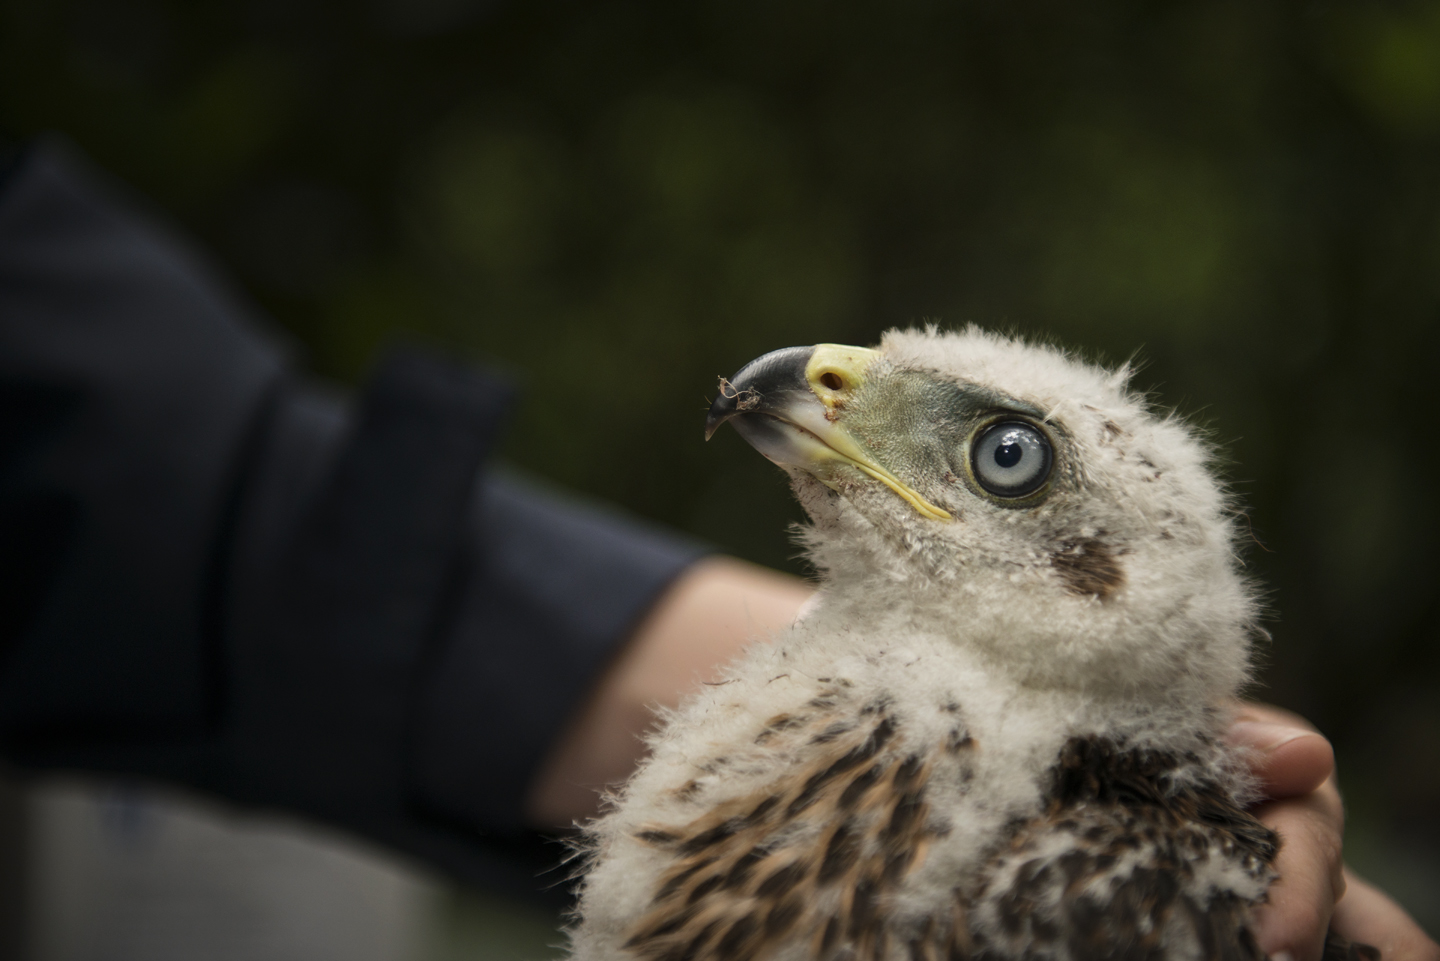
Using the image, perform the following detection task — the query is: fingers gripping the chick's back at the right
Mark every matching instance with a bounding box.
[1228,703,1440,961]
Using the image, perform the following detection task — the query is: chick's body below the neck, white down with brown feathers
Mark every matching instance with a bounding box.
[576,631,1274,961]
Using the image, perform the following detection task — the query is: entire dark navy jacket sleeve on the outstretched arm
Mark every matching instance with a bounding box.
[0,144,698,888]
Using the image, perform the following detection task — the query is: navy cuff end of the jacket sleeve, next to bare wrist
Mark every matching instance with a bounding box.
[412,477,706,833]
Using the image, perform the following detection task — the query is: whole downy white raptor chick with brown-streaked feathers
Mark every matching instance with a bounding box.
[572,328,1277,961]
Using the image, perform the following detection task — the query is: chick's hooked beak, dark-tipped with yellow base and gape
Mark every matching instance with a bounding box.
[706,344,950,520]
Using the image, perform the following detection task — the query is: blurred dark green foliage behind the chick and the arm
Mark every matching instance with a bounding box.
[0,0,1440,931]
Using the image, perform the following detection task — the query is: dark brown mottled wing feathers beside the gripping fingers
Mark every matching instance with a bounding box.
[975,738,1279,961]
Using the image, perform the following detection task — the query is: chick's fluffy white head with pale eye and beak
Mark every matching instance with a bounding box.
[706,328,1254,694]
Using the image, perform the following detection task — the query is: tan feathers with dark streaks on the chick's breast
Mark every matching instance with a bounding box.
[625,696,969,961]
